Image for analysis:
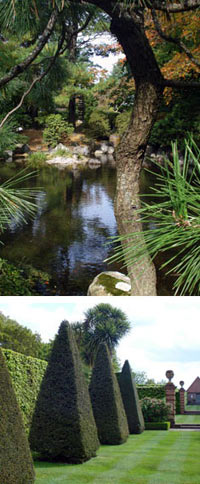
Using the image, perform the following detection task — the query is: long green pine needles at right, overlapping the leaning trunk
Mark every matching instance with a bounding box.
[110,139,200,295]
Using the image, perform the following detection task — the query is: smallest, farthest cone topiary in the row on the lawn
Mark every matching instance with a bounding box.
[118,360,145,434]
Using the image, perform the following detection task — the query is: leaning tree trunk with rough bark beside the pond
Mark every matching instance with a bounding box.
[111,12,163,296]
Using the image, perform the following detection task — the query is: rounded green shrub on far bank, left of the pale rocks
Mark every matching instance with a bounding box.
[43,114,74,148]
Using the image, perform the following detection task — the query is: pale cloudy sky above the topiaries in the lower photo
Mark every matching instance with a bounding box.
[0,296,200,390]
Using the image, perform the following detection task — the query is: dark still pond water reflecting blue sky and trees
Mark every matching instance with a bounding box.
[0,163,119,295]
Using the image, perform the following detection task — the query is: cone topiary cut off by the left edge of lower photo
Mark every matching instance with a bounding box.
[0,349,35,484]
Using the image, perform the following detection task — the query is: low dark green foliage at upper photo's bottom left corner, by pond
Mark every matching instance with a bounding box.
[0,258,49,296]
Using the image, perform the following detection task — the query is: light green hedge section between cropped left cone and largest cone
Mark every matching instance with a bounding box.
[2,349,47,431]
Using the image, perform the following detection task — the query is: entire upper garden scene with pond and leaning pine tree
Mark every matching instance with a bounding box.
[0,0,200,296]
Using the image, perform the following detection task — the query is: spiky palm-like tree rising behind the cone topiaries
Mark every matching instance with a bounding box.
[72,303,130,366]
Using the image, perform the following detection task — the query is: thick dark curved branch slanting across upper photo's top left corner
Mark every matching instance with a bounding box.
[0,10,58,87]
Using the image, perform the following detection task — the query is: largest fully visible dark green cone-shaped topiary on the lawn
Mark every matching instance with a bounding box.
[29,321,99,463]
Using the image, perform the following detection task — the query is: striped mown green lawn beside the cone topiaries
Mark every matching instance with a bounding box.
[36,431,200,484]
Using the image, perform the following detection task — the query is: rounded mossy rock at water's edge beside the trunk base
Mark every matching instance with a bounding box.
[87,271,131,296]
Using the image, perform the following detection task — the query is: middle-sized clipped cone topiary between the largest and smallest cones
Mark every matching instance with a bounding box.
[90,343,129,444]
